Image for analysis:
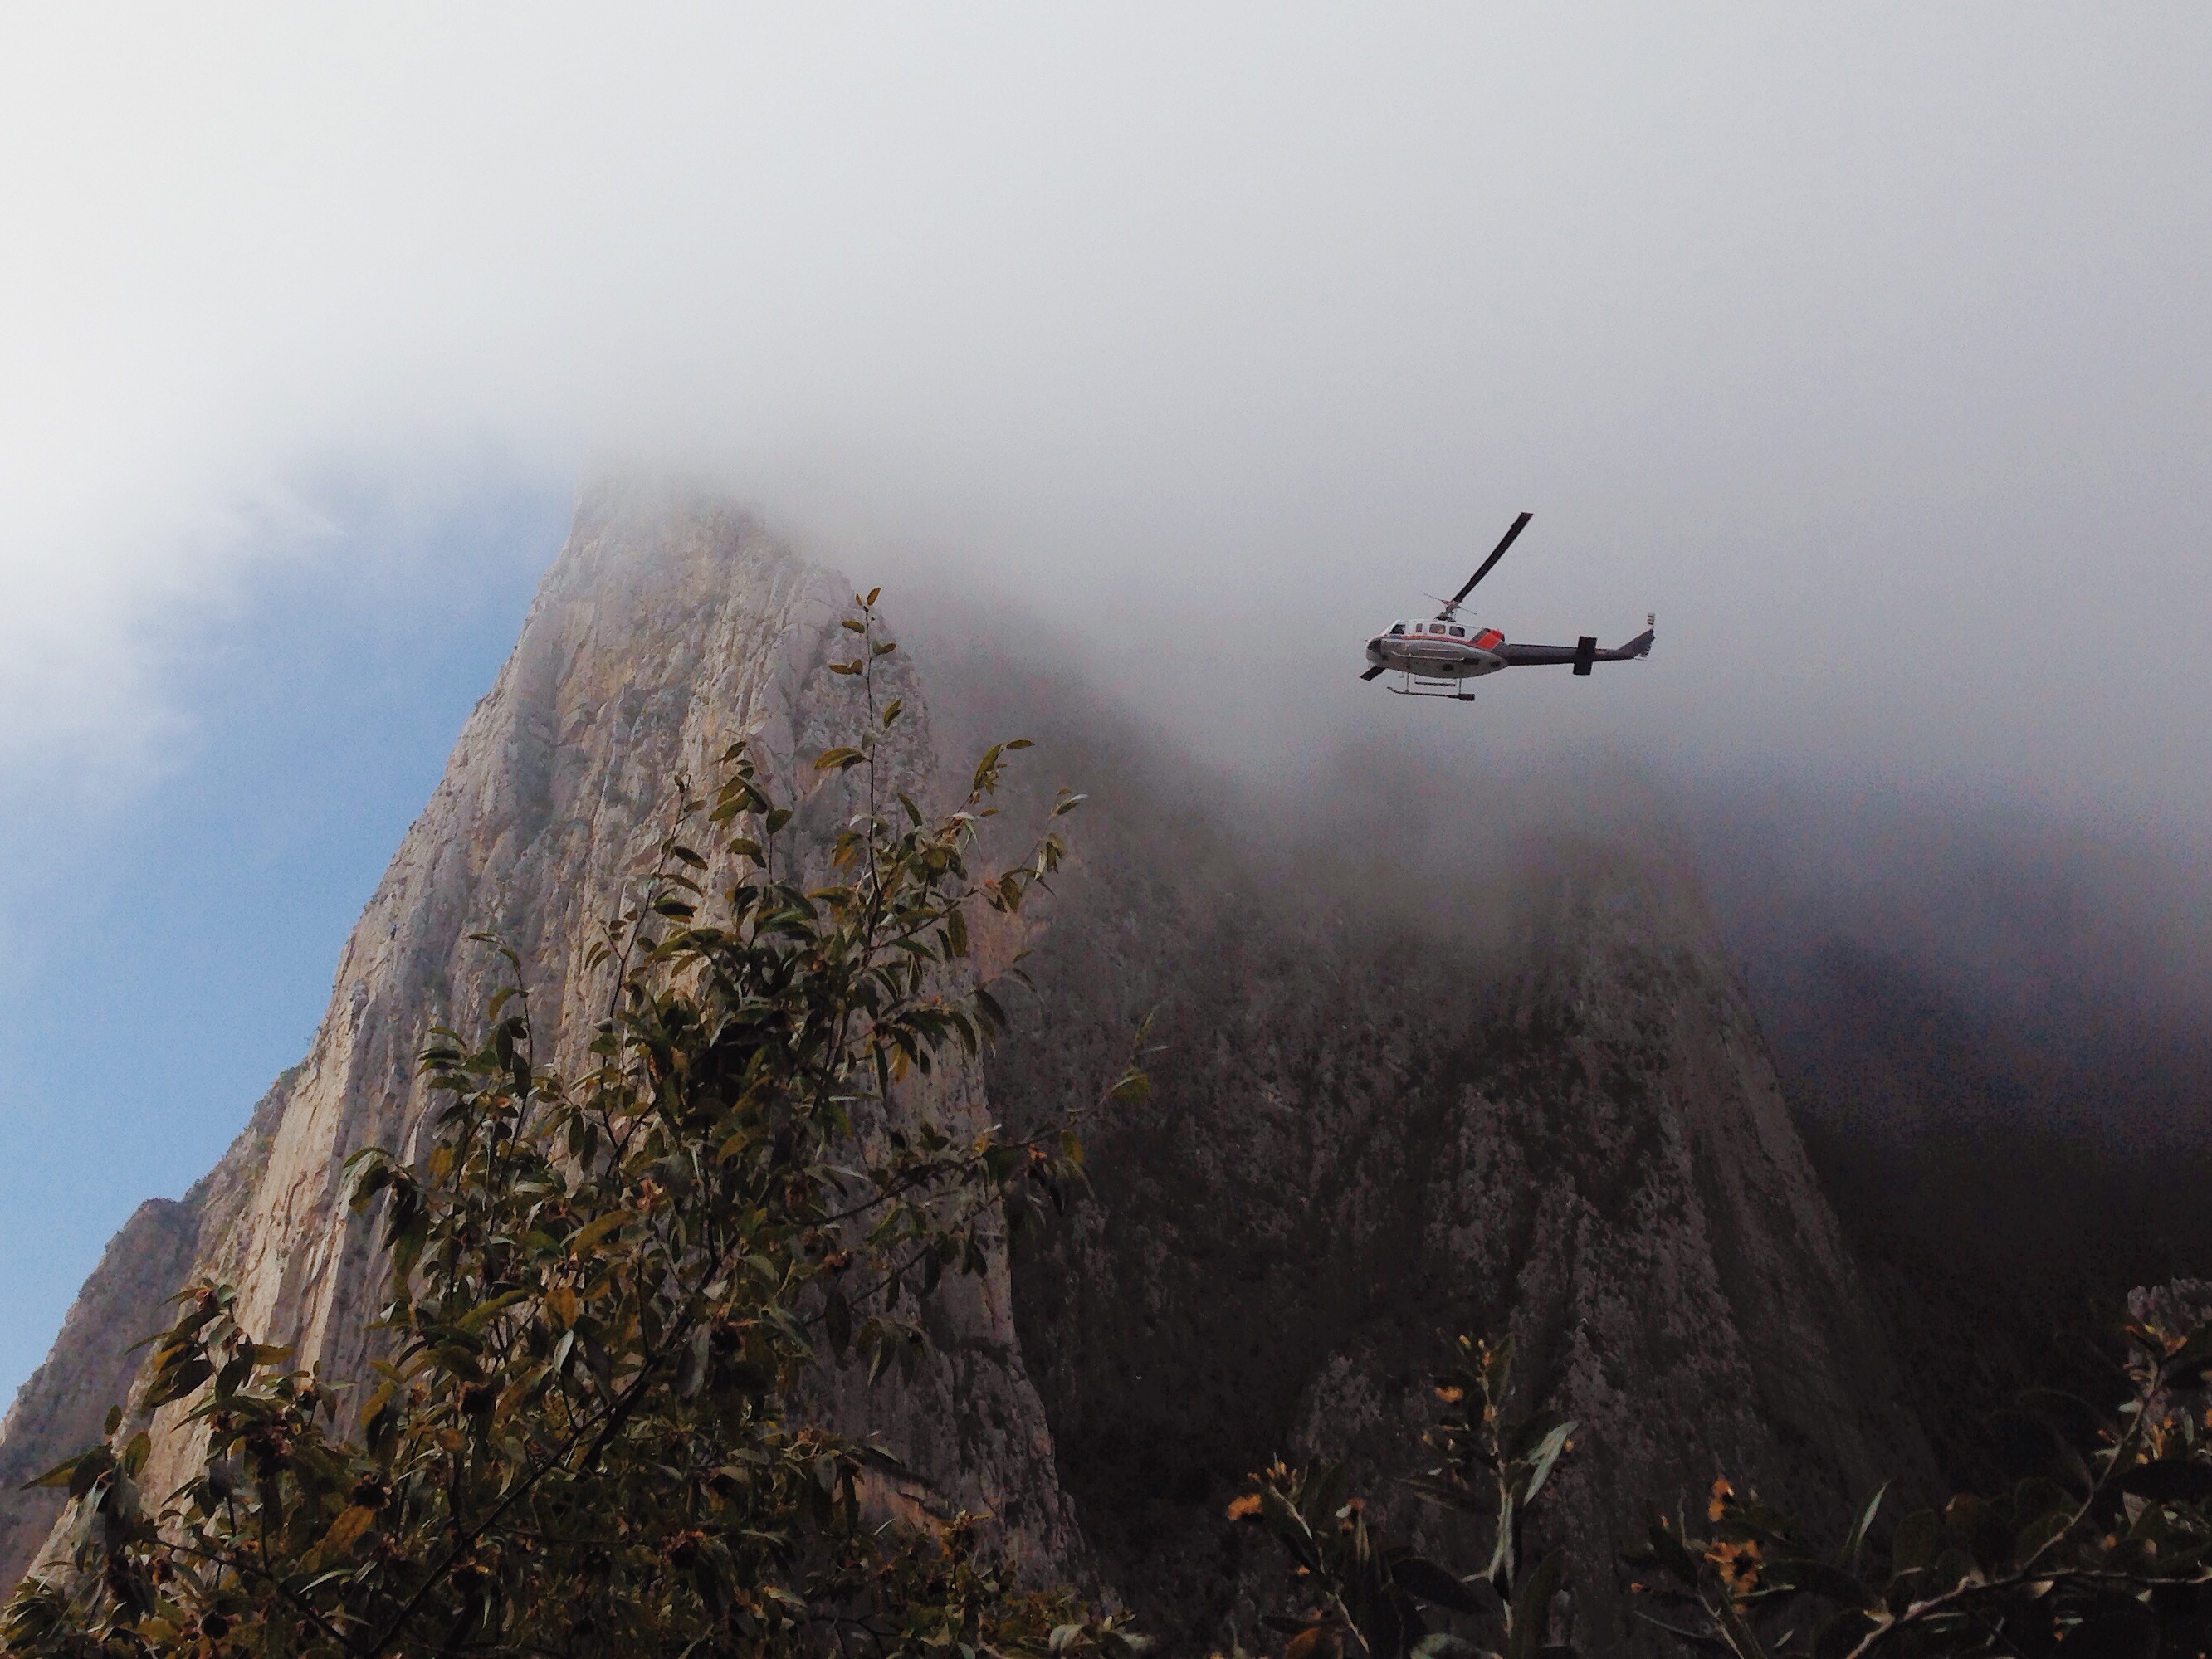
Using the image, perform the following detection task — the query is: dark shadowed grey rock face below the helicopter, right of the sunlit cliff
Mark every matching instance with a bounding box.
[989,747,1931,1652]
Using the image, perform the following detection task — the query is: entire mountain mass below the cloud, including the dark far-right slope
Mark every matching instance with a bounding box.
[0,485,2212,1652]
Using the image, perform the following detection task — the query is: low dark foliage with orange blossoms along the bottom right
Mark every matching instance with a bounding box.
[1256,1316,2212,1659]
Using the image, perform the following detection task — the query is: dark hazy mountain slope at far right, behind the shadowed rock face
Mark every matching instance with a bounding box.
[1686,778,2212,1489]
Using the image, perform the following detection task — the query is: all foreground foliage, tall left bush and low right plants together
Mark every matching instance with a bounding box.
[12,595,2212,1659]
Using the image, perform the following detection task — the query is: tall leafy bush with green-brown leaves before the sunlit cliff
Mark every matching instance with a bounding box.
[0,595,1144,1659]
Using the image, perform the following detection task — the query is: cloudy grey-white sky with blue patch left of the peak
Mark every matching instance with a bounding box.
[0,2,2212,1389]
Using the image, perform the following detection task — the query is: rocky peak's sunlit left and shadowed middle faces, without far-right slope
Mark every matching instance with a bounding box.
[0,495,1926,1652]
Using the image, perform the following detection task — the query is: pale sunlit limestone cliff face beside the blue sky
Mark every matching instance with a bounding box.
[0,493,1071,1601]
